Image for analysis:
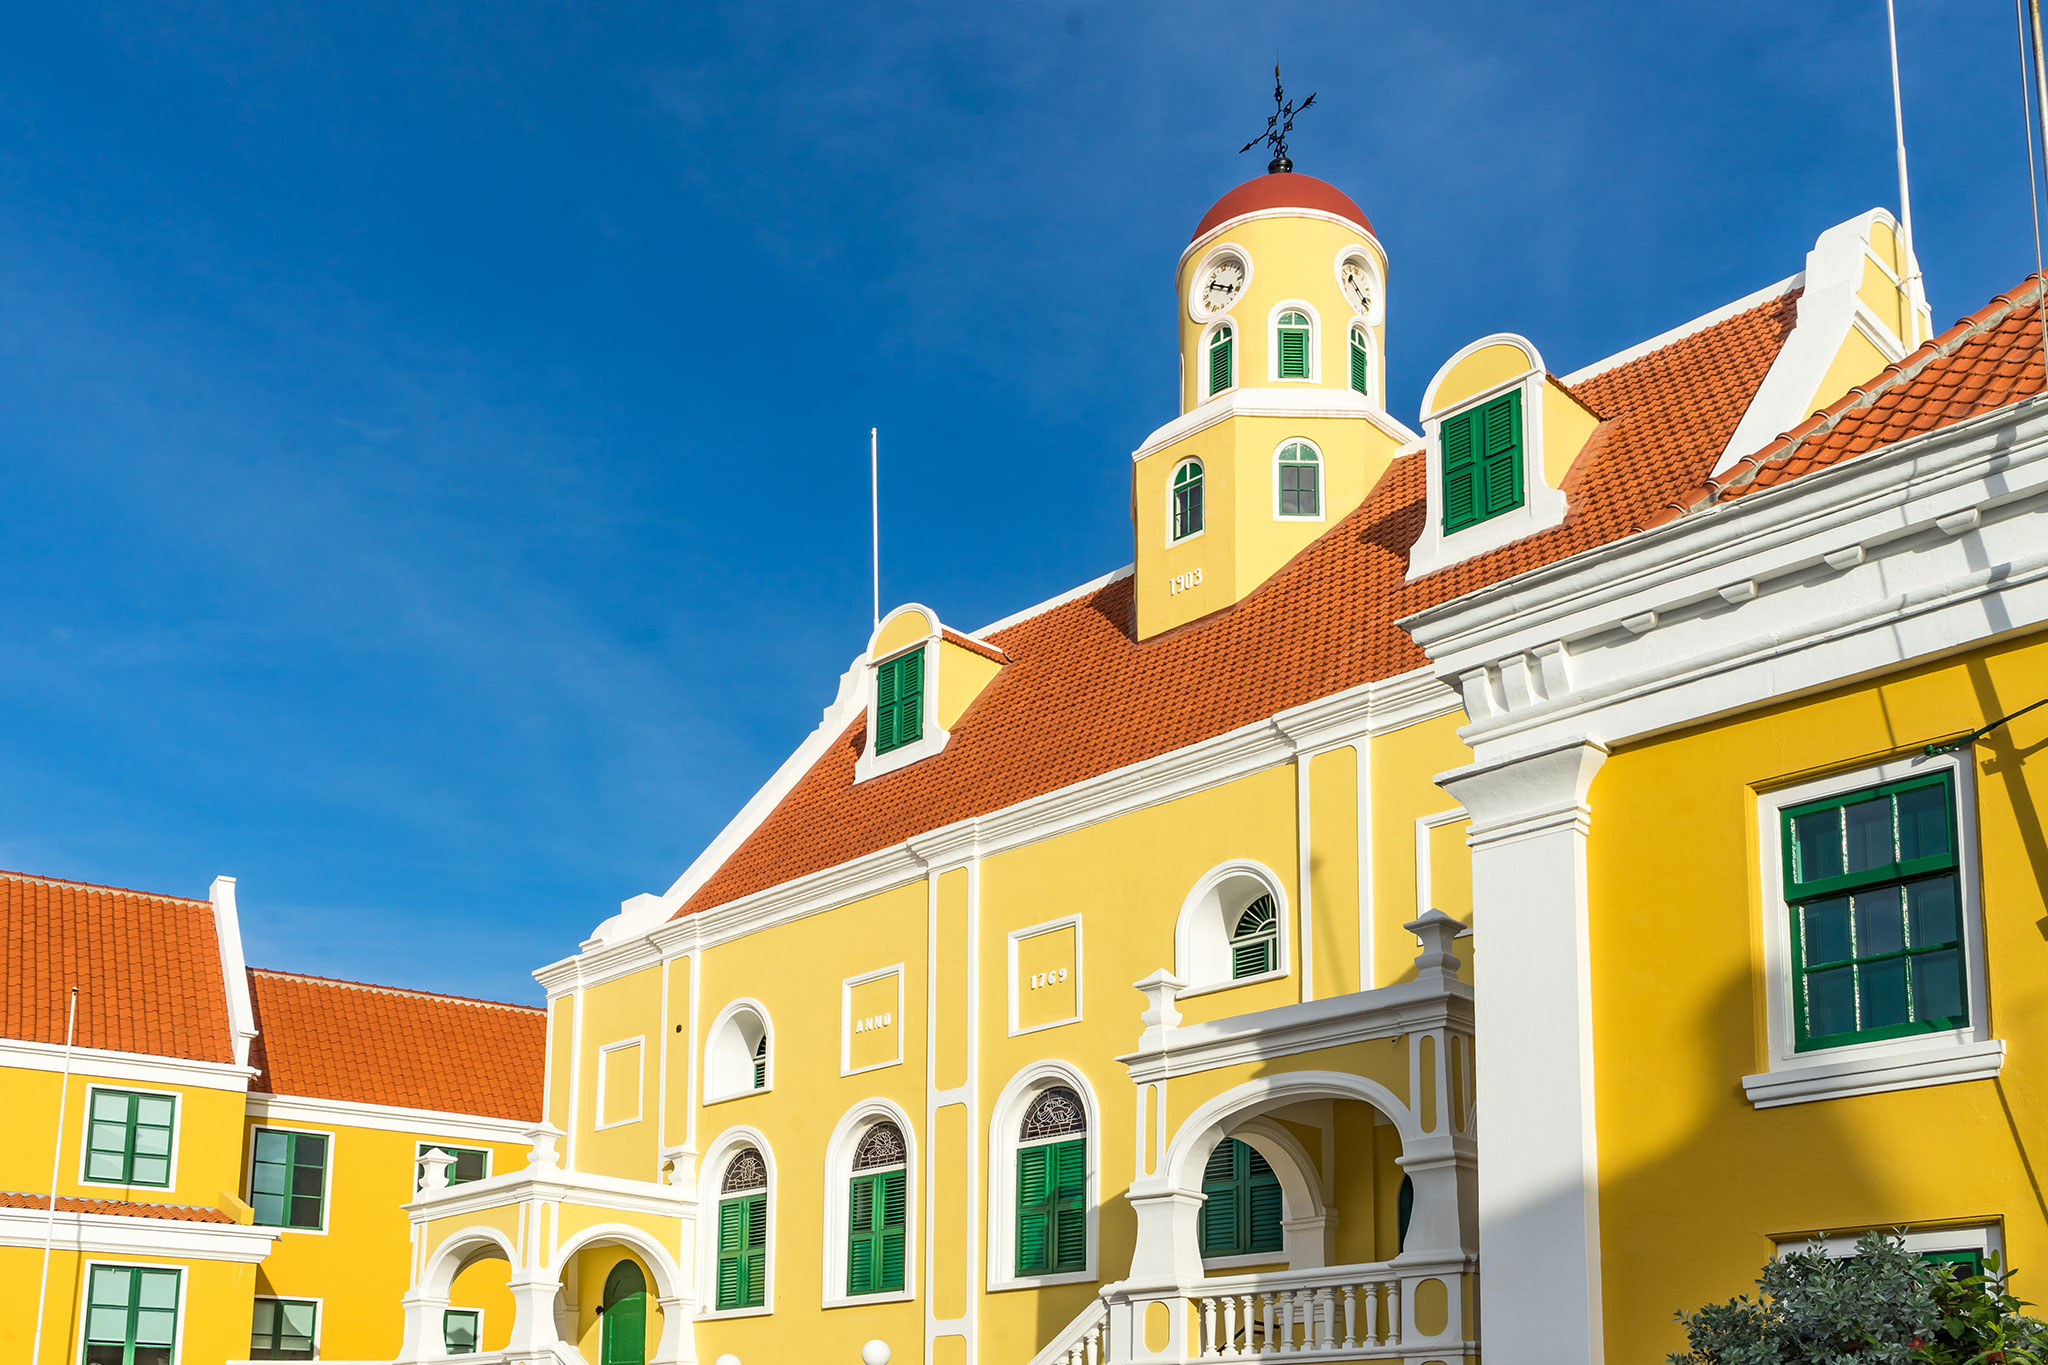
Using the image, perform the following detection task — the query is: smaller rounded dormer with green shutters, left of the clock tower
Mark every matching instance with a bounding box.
[854,602,1006,782]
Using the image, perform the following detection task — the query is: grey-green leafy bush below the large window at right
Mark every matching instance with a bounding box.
[1671,1232,2048,1365]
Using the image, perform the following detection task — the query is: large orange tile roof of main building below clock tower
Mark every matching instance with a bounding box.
[678,293,1798,915]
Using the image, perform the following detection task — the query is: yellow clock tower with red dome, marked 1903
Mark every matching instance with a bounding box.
[1130,162,1417,639]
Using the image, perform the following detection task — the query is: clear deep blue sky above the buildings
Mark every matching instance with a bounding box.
[0,0,2034,999]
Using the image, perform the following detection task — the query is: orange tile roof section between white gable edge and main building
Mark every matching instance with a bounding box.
[250,970,547,1124]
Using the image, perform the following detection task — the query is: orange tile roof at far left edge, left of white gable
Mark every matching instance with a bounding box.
[0,872,233,1062]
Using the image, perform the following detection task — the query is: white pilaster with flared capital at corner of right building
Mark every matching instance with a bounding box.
[1438,739,1608,1365]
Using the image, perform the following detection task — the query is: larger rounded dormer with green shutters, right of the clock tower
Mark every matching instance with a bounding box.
[1407,332,1599,579]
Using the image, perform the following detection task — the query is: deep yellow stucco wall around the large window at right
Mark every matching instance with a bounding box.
[1589,641,2048,1361]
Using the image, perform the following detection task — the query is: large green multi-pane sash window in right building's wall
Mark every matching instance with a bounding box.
[1780,772,1970,1050]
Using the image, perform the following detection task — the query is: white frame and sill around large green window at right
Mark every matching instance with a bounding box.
[1743,749,2005,1109]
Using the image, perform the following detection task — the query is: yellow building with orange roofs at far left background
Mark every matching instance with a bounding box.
[0,874,545,1365]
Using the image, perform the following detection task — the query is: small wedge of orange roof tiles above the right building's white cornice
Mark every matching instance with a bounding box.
[1645,276,2044,526]
